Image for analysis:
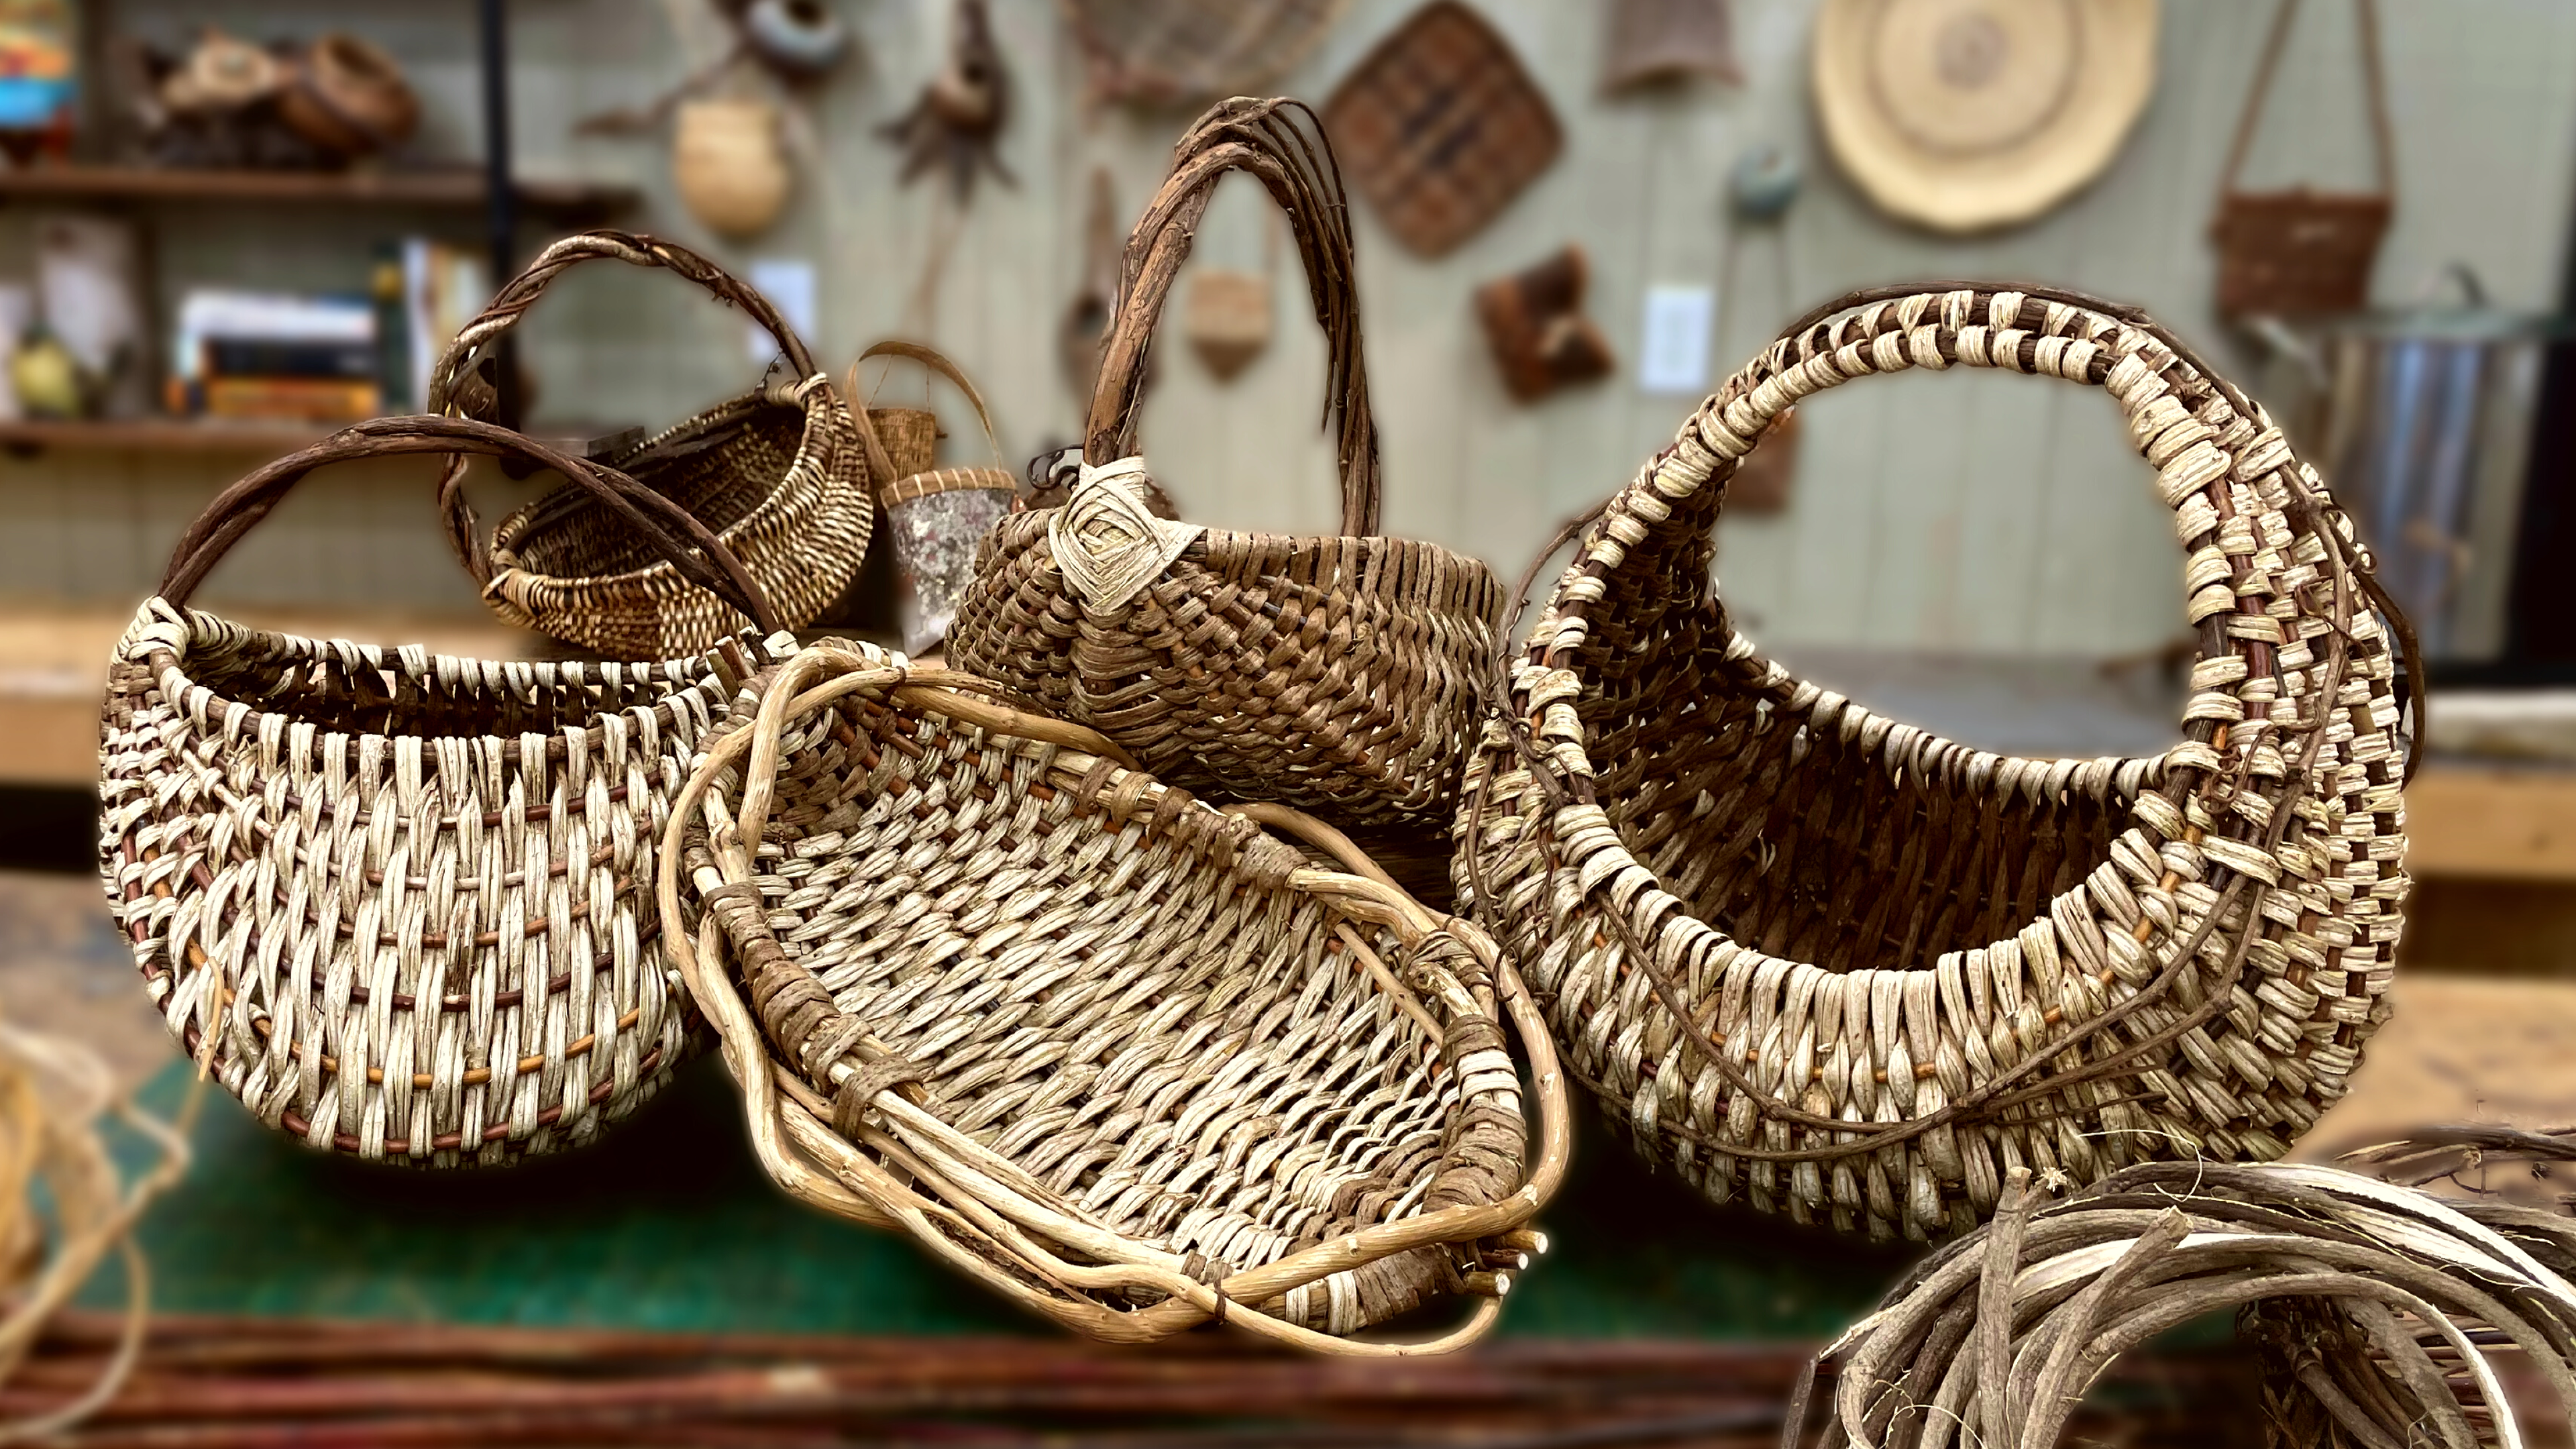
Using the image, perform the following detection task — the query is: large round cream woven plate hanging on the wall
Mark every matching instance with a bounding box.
[1816,0,2156,232]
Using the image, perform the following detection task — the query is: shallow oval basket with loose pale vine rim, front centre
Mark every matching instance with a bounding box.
[662,645,1566,1354]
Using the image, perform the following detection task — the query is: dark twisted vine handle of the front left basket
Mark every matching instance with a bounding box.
[160,415,778,634]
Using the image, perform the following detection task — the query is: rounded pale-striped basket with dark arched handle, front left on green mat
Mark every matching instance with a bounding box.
[98,418,791,1168]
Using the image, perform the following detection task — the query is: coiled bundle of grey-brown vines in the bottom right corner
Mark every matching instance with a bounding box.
[1780,1163,2576,1449]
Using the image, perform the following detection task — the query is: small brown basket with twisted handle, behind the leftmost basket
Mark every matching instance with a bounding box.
[427,232,876,660]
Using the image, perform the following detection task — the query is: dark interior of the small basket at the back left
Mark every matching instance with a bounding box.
[505,392,806,578]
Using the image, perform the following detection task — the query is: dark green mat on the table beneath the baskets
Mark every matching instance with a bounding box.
[85,1057,1909,1338]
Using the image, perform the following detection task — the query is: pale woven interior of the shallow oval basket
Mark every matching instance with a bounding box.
[726,696,1517,1266]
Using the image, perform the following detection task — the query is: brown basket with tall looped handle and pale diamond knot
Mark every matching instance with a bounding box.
[948,101,1502,825]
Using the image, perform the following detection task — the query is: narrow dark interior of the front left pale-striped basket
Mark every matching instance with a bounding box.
[163,619,724,740]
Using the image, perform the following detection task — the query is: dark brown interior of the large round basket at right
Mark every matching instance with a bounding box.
[1576,490,2128,972]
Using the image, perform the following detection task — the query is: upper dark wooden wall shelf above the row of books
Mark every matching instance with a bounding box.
[0,165,641,214]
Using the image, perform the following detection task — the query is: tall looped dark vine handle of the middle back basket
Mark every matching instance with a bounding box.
[1085,98,1381,536]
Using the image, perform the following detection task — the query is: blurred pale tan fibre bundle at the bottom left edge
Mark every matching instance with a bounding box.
[0,1024,193,1444]
